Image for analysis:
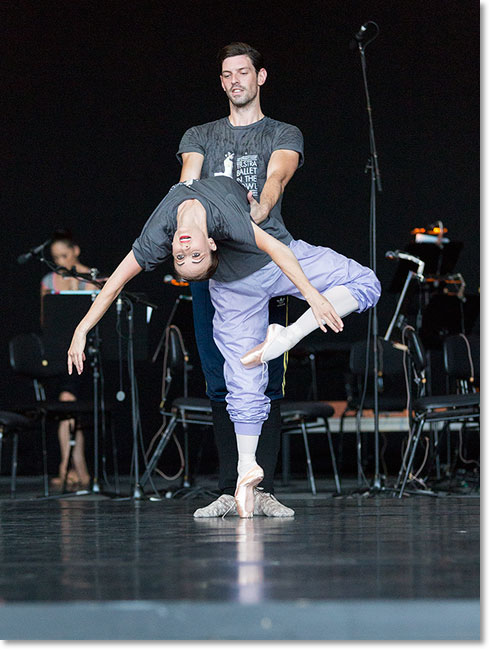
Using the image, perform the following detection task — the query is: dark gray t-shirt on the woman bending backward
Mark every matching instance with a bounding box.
[133,176,292,282]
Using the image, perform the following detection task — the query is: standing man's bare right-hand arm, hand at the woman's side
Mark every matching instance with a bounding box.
[248,149,299,224]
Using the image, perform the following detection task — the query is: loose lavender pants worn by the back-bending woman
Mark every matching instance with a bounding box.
[209,240,381,435]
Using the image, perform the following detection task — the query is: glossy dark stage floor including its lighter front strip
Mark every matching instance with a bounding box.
[0,479,480,640]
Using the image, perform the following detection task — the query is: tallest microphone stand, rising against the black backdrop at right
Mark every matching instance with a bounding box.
[356,20,382,492]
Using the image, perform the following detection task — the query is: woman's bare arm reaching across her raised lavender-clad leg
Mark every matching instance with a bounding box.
[252,223,344,332]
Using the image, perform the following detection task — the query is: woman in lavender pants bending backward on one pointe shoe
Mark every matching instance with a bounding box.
[68,176,380,517]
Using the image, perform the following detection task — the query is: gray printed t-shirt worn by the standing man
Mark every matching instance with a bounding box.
[177,117,304,221]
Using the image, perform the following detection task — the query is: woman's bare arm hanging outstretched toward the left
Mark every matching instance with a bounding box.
[68,251,142,375]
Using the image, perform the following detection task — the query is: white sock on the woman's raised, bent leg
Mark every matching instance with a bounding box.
[262,285,359,362]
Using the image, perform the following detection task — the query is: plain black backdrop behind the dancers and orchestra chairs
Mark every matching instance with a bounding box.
[0,0,480,476]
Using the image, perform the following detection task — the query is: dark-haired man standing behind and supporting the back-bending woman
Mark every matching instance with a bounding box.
[177,43,303,517]
